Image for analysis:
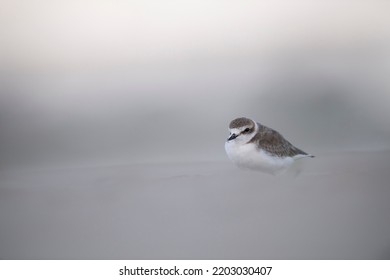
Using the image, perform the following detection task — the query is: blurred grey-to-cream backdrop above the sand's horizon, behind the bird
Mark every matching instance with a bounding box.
[0,0,390,167]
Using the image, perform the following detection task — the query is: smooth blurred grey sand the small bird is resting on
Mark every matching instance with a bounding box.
[0,151,390,259]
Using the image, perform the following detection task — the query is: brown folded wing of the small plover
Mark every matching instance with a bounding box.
[250,124,307,157]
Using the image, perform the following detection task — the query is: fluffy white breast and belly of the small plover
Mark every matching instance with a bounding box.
[225,141,294,174]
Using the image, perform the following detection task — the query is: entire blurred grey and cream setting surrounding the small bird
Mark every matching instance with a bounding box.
[0,0,390,259]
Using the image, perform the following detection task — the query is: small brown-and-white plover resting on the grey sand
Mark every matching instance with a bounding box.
[225,118,314,174]
